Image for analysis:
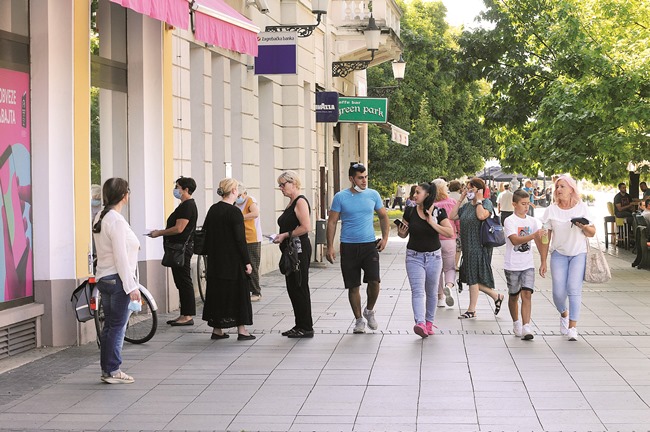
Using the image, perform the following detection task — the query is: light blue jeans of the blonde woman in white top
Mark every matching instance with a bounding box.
[551,251,587,321]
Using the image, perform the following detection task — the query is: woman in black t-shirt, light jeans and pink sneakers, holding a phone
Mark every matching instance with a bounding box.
[397,183,454,338]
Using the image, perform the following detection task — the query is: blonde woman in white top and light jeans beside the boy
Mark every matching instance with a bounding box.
[539,175,596,341]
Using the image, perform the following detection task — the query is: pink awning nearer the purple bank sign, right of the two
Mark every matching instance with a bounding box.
[192,0,260,57]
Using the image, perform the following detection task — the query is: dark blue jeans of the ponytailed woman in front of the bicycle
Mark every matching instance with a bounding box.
[97,274,131,374]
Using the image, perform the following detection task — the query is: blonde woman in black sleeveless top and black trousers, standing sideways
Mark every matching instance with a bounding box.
[273,171,314,338]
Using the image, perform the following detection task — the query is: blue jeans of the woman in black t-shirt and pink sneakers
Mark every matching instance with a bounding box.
[406,249,442,324]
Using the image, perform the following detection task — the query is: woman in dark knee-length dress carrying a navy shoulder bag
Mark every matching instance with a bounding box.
[449,177,504,319]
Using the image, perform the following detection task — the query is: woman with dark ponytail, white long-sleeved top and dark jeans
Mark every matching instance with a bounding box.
[93,178,140,384]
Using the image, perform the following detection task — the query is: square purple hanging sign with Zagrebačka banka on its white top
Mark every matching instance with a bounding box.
[255,32,298,75]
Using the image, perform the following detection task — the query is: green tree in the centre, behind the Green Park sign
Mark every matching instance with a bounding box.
[368,0,497,194]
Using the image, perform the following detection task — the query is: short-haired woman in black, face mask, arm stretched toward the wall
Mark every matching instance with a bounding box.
[149,177,199,326]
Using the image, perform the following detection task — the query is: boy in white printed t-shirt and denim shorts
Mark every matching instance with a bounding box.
[503,189,546,340]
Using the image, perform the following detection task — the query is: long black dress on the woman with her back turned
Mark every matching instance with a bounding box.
[203,201,253,328]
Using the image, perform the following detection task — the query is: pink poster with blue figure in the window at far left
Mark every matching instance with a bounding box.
[0,68,34,302]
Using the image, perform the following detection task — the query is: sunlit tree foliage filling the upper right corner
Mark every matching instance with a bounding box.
[459,0,650,183]
